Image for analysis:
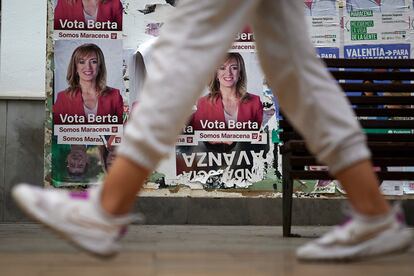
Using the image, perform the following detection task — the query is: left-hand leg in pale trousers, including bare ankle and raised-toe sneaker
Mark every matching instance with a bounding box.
[13,0,260,255]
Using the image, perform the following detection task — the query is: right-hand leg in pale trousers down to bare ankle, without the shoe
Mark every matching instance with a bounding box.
[254,0,389,214]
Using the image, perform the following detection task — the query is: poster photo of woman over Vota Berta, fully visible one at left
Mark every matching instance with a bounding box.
[53,40,124,124]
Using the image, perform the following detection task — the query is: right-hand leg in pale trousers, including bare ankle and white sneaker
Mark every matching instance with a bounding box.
[253,0,412,260]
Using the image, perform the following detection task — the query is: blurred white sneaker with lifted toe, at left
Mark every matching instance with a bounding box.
[12,184,143,257]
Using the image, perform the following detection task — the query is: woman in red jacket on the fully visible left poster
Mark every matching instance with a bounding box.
[53,43,123,124]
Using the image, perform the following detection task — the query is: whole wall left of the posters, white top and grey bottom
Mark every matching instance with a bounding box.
[0,0,47,221]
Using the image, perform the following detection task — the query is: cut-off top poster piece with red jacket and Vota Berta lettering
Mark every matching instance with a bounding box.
[54,0,123,31]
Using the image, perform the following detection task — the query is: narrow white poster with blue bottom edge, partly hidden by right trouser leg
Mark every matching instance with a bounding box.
[304,0,341,58]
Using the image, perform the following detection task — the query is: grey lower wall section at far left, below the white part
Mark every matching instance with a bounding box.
[0,100,45,221]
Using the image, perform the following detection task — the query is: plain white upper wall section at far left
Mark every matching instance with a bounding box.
[0,0,47,99]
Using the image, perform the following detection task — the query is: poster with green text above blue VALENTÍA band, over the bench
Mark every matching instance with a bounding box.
[344,0,411,59]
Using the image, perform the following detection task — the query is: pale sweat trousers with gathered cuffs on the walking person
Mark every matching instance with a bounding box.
[118,0,370,174]
